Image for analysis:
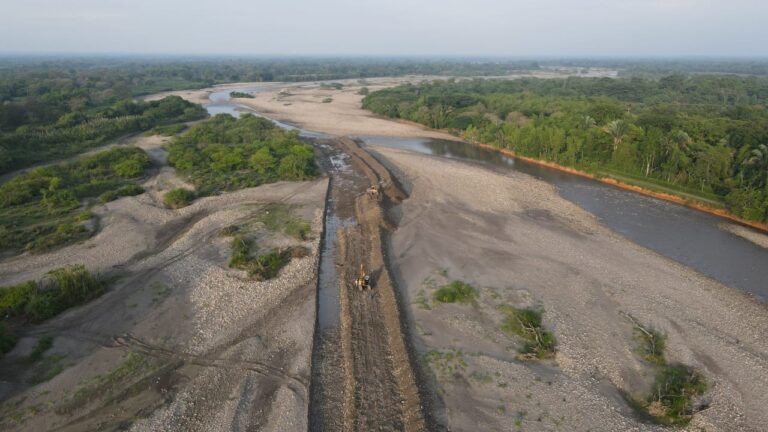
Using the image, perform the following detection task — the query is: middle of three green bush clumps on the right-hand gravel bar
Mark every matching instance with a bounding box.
[499,305,557,359]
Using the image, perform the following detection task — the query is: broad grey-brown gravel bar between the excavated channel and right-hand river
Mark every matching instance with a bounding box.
[375,147,768,431]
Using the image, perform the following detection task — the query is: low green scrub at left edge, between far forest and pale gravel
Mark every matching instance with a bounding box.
[0,147,151,253]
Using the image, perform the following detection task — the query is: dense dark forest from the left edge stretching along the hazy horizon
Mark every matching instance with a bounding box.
[0,57,536,174]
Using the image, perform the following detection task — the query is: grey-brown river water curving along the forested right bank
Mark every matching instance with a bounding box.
[361,137,768,301]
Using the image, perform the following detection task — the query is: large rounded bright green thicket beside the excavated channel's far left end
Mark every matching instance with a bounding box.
[168,114,317,196]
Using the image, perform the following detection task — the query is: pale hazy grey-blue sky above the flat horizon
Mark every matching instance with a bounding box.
[0,0,768,57]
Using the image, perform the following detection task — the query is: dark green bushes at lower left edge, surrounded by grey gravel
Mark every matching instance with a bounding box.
[0,265,106,361]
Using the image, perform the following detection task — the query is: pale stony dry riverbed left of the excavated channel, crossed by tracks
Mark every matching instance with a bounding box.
[0,139,328,431]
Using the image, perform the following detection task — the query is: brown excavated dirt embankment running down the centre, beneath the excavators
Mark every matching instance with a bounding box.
[330,138,426,431]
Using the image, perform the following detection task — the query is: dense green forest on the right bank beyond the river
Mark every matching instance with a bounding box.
[363,74,768,222]
